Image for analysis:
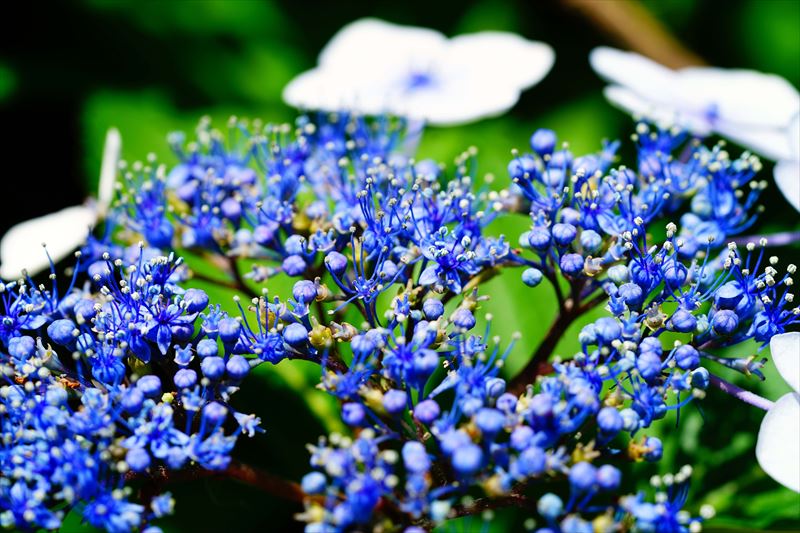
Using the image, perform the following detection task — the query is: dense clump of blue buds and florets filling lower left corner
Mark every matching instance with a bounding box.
[0,250,259,532]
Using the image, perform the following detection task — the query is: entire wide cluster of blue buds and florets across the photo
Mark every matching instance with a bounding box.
[0,115,798,533]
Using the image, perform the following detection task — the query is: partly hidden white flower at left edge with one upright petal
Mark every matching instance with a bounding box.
[0,128,122,279]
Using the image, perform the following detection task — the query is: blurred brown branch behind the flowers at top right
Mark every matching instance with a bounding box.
[561,0,705,68]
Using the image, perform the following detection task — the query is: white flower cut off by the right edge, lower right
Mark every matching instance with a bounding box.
[756,332,800,492]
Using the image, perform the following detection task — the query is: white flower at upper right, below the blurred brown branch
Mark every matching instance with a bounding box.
[589,47,800,211]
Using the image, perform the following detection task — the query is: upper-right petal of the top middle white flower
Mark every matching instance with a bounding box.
[443,31,555,89]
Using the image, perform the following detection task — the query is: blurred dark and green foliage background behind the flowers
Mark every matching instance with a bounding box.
[0,0,800,531]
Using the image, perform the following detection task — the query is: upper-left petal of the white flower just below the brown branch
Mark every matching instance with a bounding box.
[589,46,677,103]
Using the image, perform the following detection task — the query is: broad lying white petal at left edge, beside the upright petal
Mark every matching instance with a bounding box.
[0,205,97,279]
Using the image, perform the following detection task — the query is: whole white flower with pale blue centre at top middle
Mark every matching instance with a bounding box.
[283,19,555,125]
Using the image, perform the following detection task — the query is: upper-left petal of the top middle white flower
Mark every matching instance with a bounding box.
[319,18,447,73]
